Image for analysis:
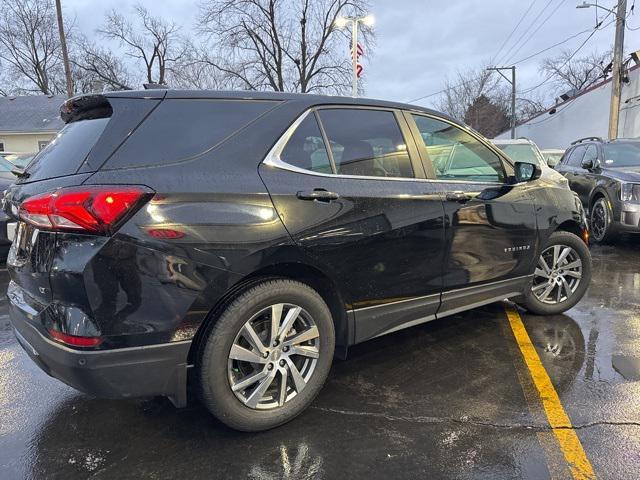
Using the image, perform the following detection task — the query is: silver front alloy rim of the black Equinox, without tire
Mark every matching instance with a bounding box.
[532,245,582,304]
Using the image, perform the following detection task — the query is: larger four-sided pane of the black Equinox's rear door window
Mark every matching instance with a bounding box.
[318,108,414,178]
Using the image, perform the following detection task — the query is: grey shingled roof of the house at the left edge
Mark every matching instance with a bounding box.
[0,95,66,133]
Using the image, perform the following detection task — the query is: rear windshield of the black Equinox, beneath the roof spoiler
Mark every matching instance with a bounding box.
[27,118,109,181]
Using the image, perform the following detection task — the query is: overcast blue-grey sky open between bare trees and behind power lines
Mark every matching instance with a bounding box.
[62,0,640,106]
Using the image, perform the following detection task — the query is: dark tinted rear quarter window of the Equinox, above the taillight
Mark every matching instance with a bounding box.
[104,99,277,169]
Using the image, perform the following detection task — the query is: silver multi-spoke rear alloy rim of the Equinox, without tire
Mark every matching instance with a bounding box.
[228,303,320,410]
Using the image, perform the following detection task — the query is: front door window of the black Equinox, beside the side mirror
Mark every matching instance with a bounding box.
[413,115,505,183]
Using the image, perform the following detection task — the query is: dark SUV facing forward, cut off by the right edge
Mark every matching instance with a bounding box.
[555,137,640,243]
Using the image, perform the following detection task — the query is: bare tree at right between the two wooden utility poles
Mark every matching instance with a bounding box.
[540,50,612,93]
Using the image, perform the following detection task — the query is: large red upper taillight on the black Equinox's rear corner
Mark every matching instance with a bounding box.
[19,185,153,235]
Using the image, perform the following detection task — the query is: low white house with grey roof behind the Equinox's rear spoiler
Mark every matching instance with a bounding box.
[0,95,66,153]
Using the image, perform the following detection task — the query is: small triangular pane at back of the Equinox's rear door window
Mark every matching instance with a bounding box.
[280,113,333,173]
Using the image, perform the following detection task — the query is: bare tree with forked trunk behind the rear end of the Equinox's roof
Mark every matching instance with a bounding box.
[97,5,185,88]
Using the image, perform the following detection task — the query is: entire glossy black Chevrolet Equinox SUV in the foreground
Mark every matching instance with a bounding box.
[5,90,591,430]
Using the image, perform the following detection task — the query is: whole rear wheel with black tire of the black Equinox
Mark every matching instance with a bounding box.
[197,279,335,432]
